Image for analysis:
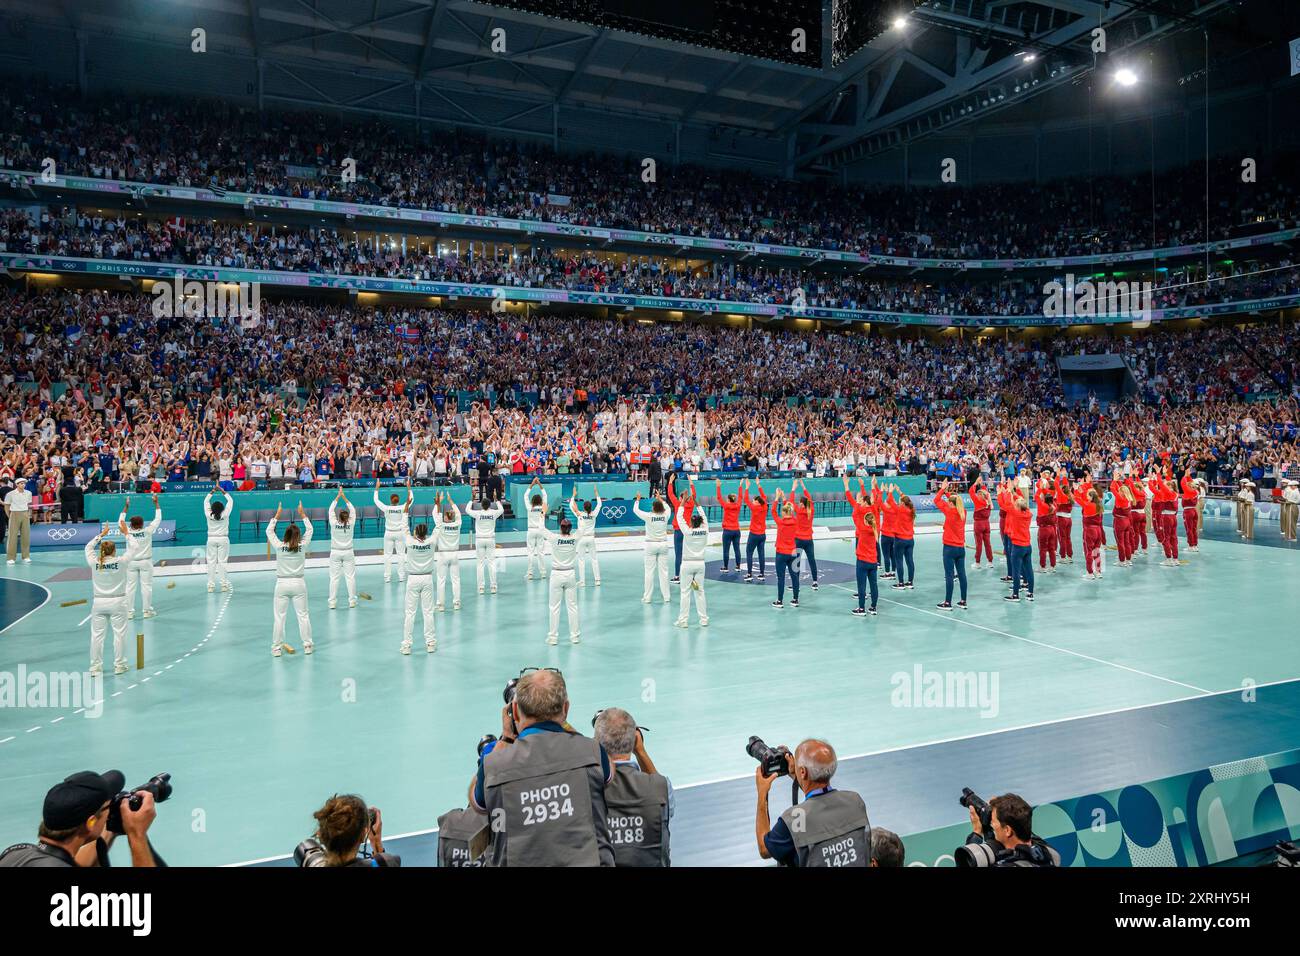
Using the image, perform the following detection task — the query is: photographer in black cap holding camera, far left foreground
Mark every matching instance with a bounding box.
[0,770,161,866]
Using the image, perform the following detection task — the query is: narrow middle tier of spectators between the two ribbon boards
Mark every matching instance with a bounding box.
[0,207,1300,316]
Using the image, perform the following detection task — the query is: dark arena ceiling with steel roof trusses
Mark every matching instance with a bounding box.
[0,0,1258,174]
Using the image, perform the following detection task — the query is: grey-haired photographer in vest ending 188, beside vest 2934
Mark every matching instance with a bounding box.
[592,708,676,866]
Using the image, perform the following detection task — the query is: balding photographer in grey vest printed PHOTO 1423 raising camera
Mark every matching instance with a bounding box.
[749,740,871,866]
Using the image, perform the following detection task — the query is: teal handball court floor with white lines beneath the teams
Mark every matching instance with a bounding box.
[0,519,1300,865]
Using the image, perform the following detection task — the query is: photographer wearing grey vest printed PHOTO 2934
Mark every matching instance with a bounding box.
[472,669,614,866]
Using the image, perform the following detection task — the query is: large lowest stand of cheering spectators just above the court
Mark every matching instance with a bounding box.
[0,290,1300,520]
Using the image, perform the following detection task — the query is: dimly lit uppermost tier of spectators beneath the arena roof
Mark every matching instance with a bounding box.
[0,83,1300,258]
